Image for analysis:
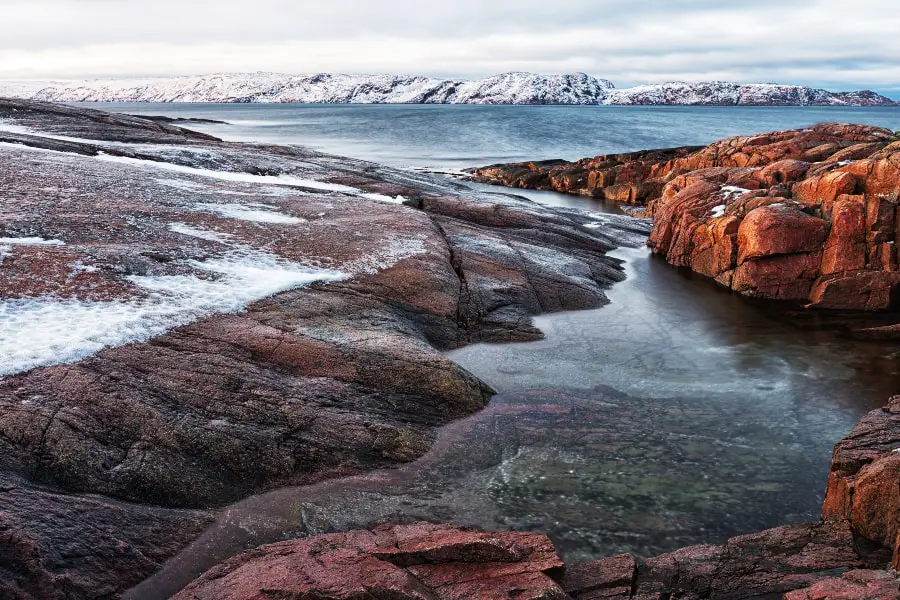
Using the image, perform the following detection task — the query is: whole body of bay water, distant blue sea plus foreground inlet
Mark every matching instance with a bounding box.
[121,104,900,598]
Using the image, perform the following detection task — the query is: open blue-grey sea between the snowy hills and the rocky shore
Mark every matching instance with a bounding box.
[82,104,900,168]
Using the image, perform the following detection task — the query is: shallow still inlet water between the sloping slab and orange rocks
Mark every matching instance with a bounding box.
[131,249,900,598]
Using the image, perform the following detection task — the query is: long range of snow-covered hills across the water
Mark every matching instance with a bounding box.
[0,73,897,106]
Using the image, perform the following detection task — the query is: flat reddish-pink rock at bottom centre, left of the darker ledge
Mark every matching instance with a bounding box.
[173,523,568,600]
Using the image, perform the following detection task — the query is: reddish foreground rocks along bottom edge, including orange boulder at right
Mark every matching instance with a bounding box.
[141,397,900,600]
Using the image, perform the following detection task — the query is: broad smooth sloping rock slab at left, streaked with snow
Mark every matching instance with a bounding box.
[0,101,646,598]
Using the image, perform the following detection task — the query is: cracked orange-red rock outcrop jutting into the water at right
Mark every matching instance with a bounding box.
[474,124,900,314]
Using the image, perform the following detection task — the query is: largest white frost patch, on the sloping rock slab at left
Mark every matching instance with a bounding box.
[0,248,348,376]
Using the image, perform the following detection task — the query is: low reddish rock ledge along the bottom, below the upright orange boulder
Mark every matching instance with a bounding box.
[174,521,900,600]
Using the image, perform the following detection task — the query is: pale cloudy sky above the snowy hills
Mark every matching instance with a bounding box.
[0,0,900,98]
